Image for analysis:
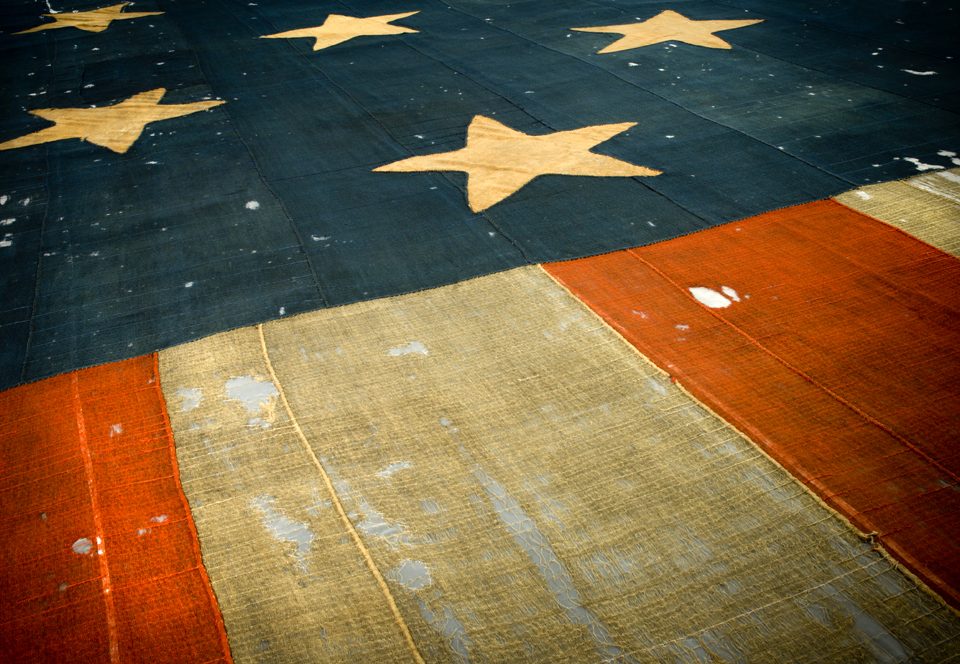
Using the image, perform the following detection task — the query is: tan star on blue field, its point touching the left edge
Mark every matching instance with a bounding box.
[0,88,224,154]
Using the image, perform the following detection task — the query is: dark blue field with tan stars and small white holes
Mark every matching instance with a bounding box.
[0,0,960,388]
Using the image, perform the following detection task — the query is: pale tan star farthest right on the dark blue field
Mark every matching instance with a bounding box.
[570,9,763,53]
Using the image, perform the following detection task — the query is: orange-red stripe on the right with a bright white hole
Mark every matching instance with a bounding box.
[545,201,960,605]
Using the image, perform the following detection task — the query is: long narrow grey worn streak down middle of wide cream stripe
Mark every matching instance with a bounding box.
[473,467,635,662]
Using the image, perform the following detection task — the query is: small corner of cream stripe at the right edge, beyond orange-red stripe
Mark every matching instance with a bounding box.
[836,168,960,256]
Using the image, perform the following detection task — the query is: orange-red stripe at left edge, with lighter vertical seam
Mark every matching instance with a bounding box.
[0,356,230,662]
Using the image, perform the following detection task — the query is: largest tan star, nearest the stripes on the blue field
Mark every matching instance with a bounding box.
[373,115,661,212]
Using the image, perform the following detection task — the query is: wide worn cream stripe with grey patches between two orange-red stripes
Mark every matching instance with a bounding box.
[161,268,960,661]
